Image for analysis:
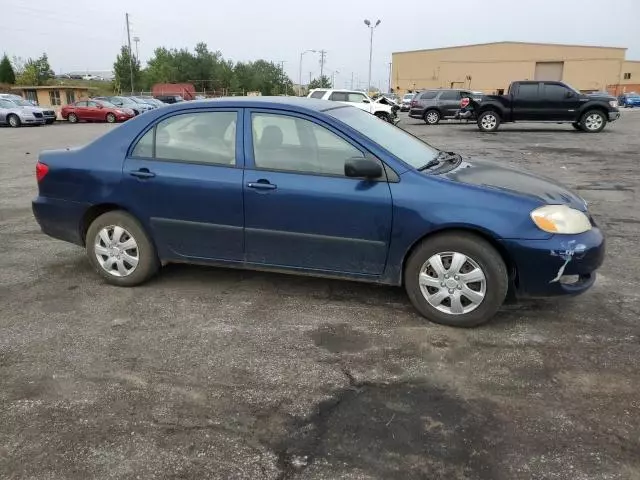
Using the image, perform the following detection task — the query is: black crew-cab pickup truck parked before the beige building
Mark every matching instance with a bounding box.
[459,81,620,133]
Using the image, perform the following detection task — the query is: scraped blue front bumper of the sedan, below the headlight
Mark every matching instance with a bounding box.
[501,227,605,297]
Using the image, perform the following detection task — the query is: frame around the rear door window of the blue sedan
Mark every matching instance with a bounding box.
[126,107,245,169]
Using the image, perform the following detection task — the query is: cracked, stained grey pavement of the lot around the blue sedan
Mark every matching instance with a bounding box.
[0,111,640,480]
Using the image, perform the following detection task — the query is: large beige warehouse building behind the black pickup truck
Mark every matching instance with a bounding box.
[391,42,640,95]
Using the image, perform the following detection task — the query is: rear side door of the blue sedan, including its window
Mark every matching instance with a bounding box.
[121,109,244,262]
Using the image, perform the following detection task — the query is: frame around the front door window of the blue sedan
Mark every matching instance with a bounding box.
[244,107,392,183]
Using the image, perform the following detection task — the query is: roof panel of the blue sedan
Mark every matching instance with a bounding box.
[158,97,348,112]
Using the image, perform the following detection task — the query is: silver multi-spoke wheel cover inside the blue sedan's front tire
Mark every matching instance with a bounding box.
[418,252,487,315]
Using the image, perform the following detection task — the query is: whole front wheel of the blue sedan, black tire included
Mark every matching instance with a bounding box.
[404,232,509,327]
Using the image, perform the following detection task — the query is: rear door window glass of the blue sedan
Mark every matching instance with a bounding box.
[132,112,238,165]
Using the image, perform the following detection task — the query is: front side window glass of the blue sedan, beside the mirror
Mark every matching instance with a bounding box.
[251,113,364,176]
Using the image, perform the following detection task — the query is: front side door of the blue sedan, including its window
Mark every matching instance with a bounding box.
[244,110,392,276]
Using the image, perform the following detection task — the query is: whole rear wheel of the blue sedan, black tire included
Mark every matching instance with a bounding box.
[85,210,160,287]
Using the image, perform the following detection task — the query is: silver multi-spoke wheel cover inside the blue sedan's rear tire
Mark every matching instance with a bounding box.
[93,225,140,277]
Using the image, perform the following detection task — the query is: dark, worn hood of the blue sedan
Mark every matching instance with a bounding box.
[442,159,587,211]
